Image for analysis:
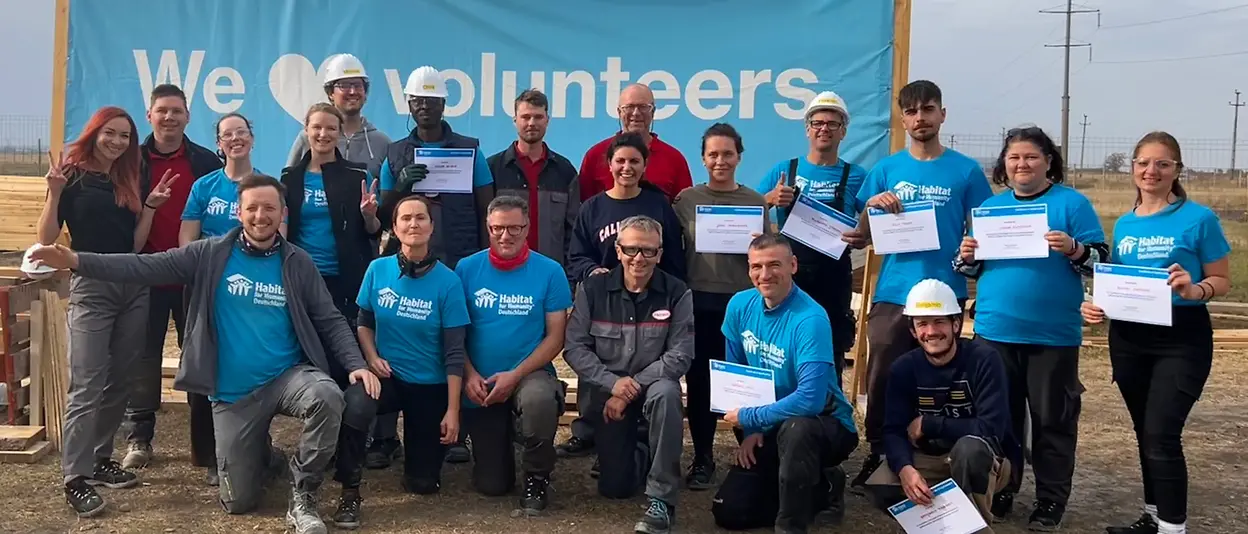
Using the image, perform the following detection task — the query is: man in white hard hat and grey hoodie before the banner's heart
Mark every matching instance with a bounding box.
[286,54,391,176]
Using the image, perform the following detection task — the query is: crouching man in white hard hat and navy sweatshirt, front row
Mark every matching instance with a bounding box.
[866,279,1017,532]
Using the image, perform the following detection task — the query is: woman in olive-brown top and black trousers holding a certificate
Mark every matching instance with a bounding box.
[674,122,768,490]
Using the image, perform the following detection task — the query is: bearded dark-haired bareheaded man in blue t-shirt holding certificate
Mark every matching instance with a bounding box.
[842,80,992,493]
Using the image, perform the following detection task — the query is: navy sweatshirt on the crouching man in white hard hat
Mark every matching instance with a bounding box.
[884,339,1012,473]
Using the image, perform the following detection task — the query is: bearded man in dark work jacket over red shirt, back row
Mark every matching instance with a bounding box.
[488,89,580,279]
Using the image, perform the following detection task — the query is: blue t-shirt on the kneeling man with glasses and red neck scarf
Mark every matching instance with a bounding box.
[456,248,572,378]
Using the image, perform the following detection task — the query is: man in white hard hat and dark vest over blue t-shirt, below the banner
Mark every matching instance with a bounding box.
[366,66,494,467]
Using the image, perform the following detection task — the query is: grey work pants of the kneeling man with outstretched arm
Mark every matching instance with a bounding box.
[212,363,346,514]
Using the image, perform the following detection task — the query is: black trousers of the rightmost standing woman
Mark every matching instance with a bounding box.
[1109,306,1213,524]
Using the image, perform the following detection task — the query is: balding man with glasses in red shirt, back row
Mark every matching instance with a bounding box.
[580,84,694,202]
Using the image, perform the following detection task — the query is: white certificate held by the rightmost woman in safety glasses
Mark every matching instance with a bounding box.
[1092,263,1173,327]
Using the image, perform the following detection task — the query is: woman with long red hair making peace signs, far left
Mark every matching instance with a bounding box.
[37,106,178,517]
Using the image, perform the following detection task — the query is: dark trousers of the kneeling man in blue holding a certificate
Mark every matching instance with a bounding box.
[711,415,859,532]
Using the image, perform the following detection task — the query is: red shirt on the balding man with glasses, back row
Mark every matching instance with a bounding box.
[579,132,694,202]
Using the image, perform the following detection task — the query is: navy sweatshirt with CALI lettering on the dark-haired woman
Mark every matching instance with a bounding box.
[568,186,685,282]
